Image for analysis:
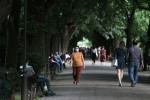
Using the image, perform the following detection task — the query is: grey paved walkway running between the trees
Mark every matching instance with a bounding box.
[41,60,150,100]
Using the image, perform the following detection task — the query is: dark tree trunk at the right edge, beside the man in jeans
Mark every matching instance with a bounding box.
[143,21,150,71]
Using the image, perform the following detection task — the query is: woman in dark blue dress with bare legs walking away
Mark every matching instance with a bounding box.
[114,41,128,86]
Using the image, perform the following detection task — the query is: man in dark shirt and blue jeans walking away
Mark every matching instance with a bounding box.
[128,40,144,87]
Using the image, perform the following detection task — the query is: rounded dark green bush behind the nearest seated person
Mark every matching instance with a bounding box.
[27,52,46,73]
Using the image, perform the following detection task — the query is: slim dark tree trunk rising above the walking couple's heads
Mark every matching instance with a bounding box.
[125,9,135,48]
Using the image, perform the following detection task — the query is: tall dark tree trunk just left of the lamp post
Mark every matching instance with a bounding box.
[5,0,21,69]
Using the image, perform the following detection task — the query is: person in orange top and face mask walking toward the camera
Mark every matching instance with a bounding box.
[71,46,85,85]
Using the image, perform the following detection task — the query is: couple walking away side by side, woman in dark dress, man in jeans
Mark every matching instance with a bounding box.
[114,40,144,87]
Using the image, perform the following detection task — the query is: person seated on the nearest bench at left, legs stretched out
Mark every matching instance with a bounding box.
[20,61,56,96]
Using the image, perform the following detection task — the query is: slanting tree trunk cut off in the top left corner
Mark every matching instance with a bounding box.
[0,0,12,29]
